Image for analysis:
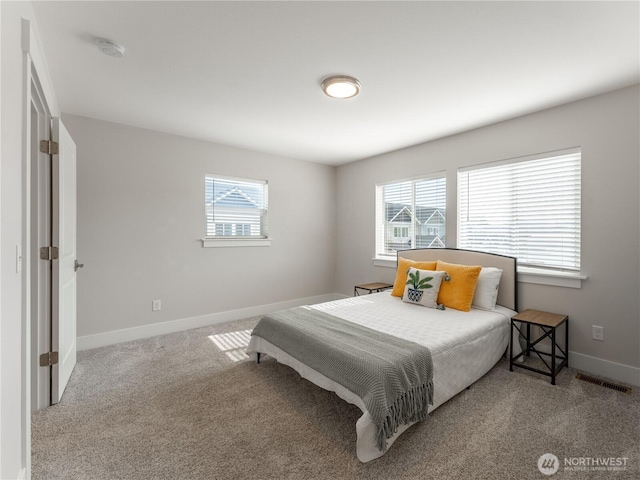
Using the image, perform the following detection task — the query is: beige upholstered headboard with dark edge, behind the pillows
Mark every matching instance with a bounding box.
[398,248,518,312]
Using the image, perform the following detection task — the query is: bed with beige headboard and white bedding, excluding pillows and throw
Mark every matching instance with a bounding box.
[246,249,520,462]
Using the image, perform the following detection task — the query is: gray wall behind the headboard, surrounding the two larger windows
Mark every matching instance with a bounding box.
[336,86,640,368]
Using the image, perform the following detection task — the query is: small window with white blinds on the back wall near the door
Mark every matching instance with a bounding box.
[205,175,268,239]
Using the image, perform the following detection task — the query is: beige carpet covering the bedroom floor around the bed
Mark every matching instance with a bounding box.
[32,319,640,480]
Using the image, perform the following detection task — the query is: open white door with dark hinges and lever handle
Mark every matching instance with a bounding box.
[51,118,77,404]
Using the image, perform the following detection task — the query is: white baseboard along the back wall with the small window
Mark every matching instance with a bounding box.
[77,293,344,350]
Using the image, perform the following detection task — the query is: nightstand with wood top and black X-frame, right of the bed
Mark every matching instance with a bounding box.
[509,310,569,385]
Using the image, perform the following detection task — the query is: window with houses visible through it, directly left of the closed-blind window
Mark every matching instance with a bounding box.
[376,173,446,259]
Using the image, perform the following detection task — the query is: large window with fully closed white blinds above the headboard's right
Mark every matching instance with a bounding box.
[458,149,581,271]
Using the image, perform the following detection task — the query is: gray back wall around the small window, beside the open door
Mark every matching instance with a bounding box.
[63,115,336,337]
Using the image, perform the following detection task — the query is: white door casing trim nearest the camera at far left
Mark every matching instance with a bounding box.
[18,18,60,478]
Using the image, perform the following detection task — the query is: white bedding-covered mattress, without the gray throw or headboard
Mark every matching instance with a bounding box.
[247,291,520,462]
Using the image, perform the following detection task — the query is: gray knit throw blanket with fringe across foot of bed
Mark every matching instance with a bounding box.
[251,307,433,452]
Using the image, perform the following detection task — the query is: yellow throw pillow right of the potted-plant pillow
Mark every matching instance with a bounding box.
[436,260,482,312]
